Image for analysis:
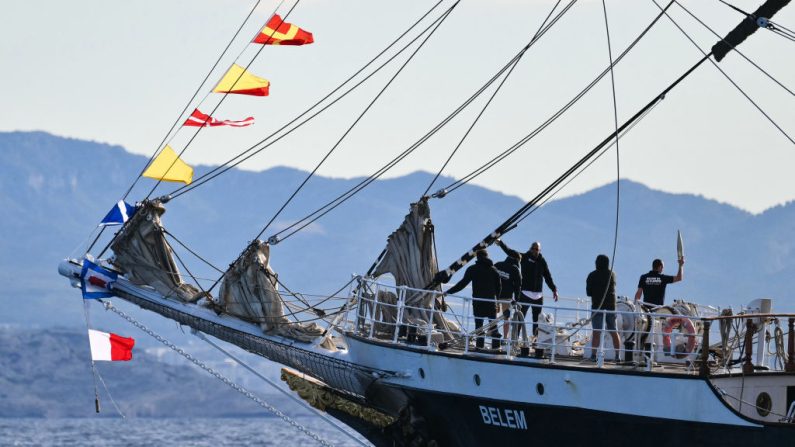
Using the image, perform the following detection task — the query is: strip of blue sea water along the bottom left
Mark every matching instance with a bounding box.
[0,416,370,447]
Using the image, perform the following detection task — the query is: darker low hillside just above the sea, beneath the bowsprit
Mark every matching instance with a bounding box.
[0,328,300,417]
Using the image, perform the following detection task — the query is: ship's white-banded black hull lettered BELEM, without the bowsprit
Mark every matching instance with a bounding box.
[349,337,795,446]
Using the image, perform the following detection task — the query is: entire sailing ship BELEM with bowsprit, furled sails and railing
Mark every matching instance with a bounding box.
[59,0,795,446]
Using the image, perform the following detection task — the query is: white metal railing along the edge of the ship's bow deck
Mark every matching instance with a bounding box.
[344,278,795,374]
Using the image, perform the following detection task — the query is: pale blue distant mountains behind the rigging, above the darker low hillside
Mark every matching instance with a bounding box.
[0,132,795,332]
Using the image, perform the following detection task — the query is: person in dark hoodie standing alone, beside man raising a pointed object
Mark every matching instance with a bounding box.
[585,255,621,360]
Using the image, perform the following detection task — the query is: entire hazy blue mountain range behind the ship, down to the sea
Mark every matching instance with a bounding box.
[0,132,795,417]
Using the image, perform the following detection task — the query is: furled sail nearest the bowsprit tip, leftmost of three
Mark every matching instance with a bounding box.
[111,200,203,302]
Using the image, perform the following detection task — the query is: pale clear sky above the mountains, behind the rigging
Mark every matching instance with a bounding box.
[0,0,795,213]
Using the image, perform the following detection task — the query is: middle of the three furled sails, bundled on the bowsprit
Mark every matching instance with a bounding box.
[216,240,323,342]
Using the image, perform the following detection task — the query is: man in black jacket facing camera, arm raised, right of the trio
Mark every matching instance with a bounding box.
[497,239,558,335]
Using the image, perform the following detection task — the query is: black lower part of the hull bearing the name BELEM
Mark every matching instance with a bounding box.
[402,389,795,447]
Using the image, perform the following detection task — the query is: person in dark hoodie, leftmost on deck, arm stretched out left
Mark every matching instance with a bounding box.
[445,250,501,348]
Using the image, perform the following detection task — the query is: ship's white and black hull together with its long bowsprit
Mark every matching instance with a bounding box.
[57,265,795,447]
